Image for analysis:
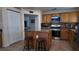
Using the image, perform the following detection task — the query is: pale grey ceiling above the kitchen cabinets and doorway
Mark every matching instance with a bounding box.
[24,7,76,12]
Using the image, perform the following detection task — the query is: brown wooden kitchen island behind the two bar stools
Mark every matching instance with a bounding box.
[25,30,52,50]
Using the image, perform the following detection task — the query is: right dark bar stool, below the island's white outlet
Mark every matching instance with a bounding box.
[36,38,46,51]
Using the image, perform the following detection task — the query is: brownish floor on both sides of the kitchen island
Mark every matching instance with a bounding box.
[0,40,73,51]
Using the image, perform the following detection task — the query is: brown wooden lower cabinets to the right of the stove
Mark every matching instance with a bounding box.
[61,29,75,44]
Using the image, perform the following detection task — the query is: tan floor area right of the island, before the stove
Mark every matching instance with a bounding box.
[50,40,72,51]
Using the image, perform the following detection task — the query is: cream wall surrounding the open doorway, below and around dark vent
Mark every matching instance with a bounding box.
[22,9,42,31]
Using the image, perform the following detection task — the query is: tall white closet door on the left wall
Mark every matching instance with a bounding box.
[7,10,21,44]
